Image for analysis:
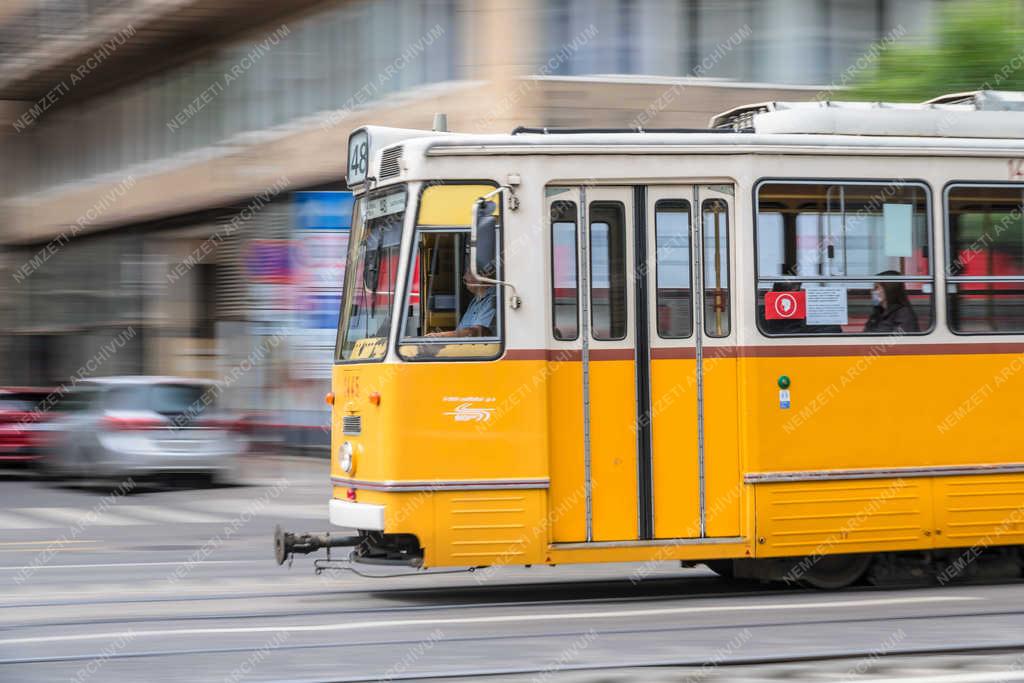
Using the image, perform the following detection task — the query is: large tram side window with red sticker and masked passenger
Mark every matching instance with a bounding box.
[757,181,934,336]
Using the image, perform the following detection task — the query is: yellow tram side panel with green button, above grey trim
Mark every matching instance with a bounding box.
[741,352,1024,473]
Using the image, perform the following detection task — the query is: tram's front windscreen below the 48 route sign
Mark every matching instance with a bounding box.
[337,187,407,360]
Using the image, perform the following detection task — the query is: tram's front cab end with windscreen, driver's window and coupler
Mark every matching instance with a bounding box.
[275,129,547,568]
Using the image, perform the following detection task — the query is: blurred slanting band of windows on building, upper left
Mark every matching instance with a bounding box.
[0,0,460,195]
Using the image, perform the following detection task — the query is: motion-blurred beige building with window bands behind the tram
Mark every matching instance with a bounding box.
[0,0,939,442]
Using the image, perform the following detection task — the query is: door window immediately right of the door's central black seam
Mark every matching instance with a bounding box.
[654,200,693,339]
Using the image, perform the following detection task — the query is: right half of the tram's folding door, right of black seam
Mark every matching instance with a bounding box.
[641,185,741,539]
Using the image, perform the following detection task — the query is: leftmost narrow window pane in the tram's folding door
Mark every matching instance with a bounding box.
[551,202,580,341]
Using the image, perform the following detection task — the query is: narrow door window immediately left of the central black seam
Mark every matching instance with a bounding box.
[590,202,628,341]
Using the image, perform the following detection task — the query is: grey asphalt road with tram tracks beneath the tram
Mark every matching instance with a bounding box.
[0,458,1024,683]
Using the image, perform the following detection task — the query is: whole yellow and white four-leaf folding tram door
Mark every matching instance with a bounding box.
[548,185,739,542]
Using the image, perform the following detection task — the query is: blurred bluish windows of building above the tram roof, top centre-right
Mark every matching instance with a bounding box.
[535,0,934,86]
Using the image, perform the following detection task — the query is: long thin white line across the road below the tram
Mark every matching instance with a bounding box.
[0,595,984,645]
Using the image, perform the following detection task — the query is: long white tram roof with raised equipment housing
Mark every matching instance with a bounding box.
[366,91,1024,187]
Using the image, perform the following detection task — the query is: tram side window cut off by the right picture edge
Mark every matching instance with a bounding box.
[946,185,1024,334]
